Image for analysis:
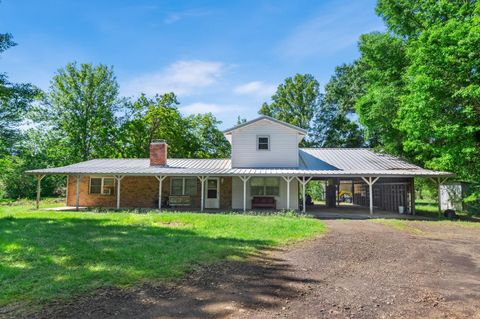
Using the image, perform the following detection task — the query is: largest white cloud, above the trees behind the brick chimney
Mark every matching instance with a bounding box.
[124,60,226,95]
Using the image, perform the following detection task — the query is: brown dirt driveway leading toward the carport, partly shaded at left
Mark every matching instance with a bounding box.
[30,220,480,318]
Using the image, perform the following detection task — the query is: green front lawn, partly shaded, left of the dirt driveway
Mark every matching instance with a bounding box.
[0,204,325,306]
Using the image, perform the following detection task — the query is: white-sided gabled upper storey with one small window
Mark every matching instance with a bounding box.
[224,116,306,168]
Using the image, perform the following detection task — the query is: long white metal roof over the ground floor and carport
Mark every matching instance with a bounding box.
[27,148,453,177]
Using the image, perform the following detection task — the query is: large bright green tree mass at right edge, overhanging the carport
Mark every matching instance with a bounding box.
[326,0,480,209]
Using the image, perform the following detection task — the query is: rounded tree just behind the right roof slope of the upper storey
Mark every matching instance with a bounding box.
[258,74,321,143]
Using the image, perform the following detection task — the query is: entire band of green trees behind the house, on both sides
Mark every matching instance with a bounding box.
[0,0,480,209]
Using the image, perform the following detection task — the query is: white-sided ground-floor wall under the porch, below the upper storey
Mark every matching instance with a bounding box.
[232,177,299,209]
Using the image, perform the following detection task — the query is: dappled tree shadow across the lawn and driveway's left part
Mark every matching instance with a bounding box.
[0,217,320,318]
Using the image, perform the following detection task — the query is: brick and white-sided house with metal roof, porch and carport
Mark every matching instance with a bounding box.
[27,116,452,213]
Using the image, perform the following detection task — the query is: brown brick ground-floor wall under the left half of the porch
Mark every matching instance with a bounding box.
[67,176,232,209]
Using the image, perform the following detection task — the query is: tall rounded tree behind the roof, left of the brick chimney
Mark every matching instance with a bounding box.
[46,63,119,162]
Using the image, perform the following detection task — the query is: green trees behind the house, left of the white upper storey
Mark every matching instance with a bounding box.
[0,58,230,198]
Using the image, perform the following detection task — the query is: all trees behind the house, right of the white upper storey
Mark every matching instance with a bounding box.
[260,0,480,210]
